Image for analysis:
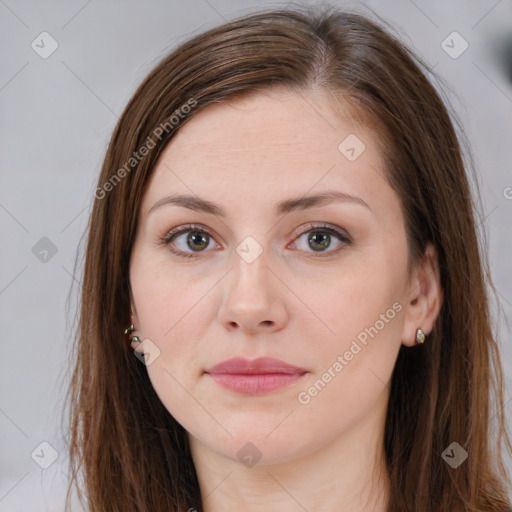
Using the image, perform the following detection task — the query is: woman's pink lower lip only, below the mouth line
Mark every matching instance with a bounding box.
[208,373,304,395]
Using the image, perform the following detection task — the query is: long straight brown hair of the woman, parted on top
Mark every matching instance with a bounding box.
[66,6,512,512]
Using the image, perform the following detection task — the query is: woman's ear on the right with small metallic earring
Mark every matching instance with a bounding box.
[402,242,444,347]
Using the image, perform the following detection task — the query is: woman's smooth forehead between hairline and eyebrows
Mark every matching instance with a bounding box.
[144,90,392,216]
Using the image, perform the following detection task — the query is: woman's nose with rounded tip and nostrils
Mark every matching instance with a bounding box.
[219,248,288,334]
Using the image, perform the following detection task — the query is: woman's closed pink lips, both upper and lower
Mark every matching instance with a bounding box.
[205,357,307,395]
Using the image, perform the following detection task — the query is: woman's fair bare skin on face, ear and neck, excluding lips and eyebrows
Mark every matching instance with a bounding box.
[130,86,442,512]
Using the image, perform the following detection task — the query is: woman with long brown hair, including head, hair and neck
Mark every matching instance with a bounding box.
[64,4,511,512]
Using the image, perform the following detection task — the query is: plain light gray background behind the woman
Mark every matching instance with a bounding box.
[0,0,512,512]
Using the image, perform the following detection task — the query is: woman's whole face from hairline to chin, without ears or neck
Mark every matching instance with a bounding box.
[130,87,416,464]
